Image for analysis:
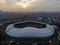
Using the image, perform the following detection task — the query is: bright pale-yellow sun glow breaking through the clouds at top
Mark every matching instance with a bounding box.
[16,0,35,8]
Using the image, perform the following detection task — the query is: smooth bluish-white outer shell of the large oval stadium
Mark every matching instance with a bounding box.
[5,22,55,37]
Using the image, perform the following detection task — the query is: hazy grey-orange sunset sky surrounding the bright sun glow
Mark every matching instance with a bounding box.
[0,0,60,12]
